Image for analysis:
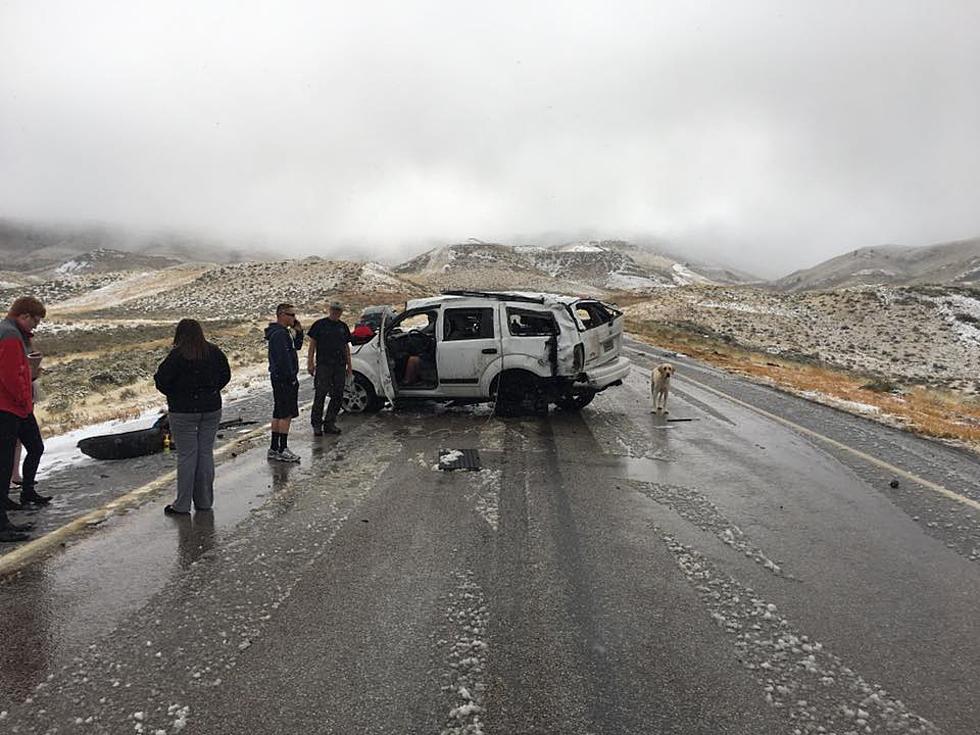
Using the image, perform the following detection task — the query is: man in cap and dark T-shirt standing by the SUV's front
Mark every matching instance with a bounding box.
[306,301,354,436]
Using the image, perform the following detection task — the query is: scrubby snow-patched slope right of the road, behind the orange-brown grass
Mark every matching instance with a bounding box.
[626,286,980,394]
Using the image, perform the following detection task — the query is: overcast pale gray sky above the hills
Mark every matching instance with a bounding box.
[0,0,980,275]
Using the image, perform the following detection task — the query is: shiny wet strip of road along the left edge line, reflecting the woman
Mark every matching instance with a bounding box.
[0,447,290,698]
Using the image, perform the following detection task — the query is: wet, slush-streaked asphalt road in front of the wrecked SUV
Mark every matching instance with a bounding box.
[0,345,980,735]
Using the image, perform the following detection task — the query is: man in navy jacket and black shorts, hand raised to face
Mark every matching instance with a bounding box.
[265,304,303,462]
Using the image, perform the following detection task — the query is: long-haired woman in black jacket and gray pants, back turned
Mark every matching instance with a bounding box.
[153,319,231,515]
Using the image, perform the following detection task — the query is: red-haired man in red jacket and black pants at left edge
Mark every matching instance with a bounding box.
[0,296,50,542]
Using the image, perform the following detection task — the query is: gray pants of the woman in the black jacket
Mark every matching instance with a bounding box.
[170,409,221,513]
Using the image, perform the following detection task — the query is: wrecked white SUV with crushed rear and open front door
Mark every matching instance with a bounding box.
[343,291,630,413]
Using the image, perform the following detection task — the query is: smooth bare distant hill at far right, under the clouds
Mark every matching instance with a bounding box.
[774,237,980,291]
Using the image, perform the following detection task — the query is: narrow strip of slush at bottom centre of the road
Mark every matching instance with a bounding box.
[439,570,490,735]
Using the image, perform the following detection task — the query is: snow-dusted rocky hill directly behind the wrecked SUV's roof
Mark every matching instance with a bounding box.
[395,240,740,294]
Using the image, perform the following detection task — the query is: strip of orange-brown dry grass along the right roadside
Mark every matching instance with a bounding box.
[627,322,980,451]
